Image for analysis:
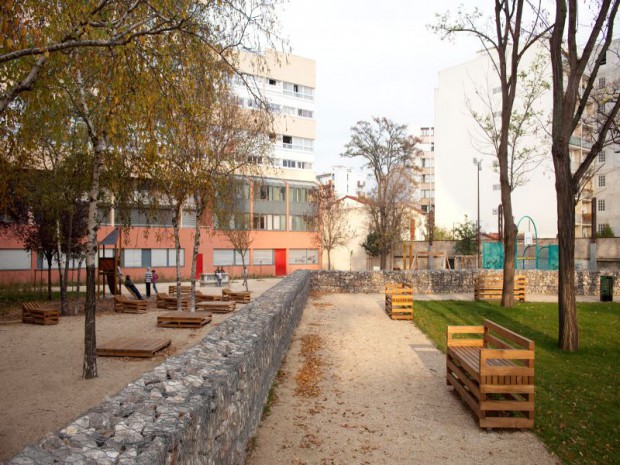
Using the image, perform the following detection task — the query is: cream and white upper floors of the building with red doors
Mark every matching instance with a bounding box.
[233,51,316,183]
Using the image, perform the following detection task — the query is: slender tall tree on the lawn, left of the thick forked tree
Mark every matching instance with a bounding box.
[432,0,547,307]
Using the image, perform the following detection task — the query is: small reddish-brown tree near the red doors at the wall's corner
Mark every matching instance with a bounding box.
[315,186,353,270]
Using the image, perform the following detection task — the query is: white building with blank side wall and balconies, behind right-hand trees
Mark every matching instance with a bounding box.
[435,42,596,237]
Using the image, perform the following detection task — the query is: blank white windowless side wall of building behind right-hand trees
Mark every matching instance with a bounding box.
[435,44,557,237]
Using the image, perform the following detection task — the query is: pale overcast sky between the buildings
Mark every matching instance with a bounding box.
[279,0,491,174]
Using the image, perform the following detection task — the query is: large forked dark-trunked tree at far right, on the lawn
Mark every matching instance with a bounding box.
[549,0,620,351]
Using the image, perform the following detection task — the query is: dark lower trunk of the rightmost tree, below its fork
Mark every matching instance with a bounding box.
[554,149,579,352]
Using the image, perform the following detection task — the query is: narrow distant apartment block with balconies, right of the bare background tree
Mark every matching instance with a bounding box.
[414,127,435,213]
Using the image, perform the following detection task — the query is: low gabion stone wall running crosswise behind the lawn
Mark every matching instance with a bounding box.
[312,270,620,295]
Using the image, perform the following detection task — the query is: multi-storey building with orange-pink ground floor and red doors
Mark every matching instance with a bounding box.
[0,51,321,283]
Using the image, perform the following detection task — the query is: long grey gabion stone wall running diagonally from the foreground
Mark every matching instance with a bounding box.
[8,271,311,465]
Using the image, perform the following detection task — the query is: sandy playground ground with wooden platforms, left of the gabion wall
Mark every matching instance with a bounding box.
[0,279,279,461]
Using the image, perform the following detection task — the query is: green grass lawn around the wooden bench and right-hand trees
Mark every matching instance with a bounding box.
[415,301,620,465]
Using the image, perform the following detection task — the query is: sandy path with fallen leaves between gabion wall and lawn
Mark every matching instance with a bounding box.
[246,294,559,465]
